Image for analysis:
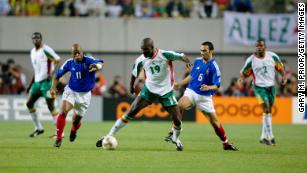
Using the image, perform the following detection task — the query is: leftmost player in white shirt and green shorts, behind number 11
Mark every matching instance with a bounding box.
[27,32,60,137]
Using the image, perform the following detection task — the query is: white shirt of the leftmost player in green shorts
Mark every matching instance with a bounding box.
[30,44,60,82]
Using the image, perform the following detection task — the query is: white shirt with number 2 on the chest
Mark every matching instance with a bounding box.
[240,51,283,87]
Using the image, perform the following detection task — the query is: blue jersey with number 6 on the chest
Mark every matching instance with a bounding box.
[188,57,221,96]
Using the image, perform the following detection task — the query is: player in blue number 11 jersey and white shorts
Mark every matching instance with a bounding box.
[51,44,103,147]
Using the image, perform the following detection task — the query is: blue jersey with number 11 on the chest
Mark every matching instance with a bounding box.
[56,55,103,92]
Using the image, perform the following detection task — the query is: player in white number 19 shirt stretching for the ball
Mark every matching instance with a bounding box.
[96,38,190,151]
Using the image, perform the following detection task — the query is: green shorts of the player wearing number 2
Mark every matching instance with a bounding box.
[254,85,275,105]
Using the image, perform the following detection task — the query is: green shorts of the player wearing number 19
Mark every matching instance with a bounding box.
[140,85,177,107]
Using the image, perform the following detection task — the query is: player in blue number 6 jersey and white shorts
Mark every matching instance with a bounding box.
[165,41,238,151]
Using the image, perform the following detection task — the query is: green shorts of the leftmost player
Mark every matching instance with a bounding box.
[30,80,52,99]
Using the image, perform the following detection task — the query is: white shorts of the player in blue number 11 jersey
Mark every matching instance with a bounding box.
[62,86,92,117]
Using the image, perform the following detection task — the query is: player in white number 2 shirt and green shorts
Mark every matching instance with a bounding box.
[238,39,287,145]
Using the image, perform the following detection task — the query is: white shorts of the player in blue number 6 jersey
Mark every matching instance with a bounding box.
[184,88,215,113]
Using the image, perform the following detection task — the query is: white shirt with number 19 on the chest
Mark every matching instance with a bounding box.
[132,49,184,96]
